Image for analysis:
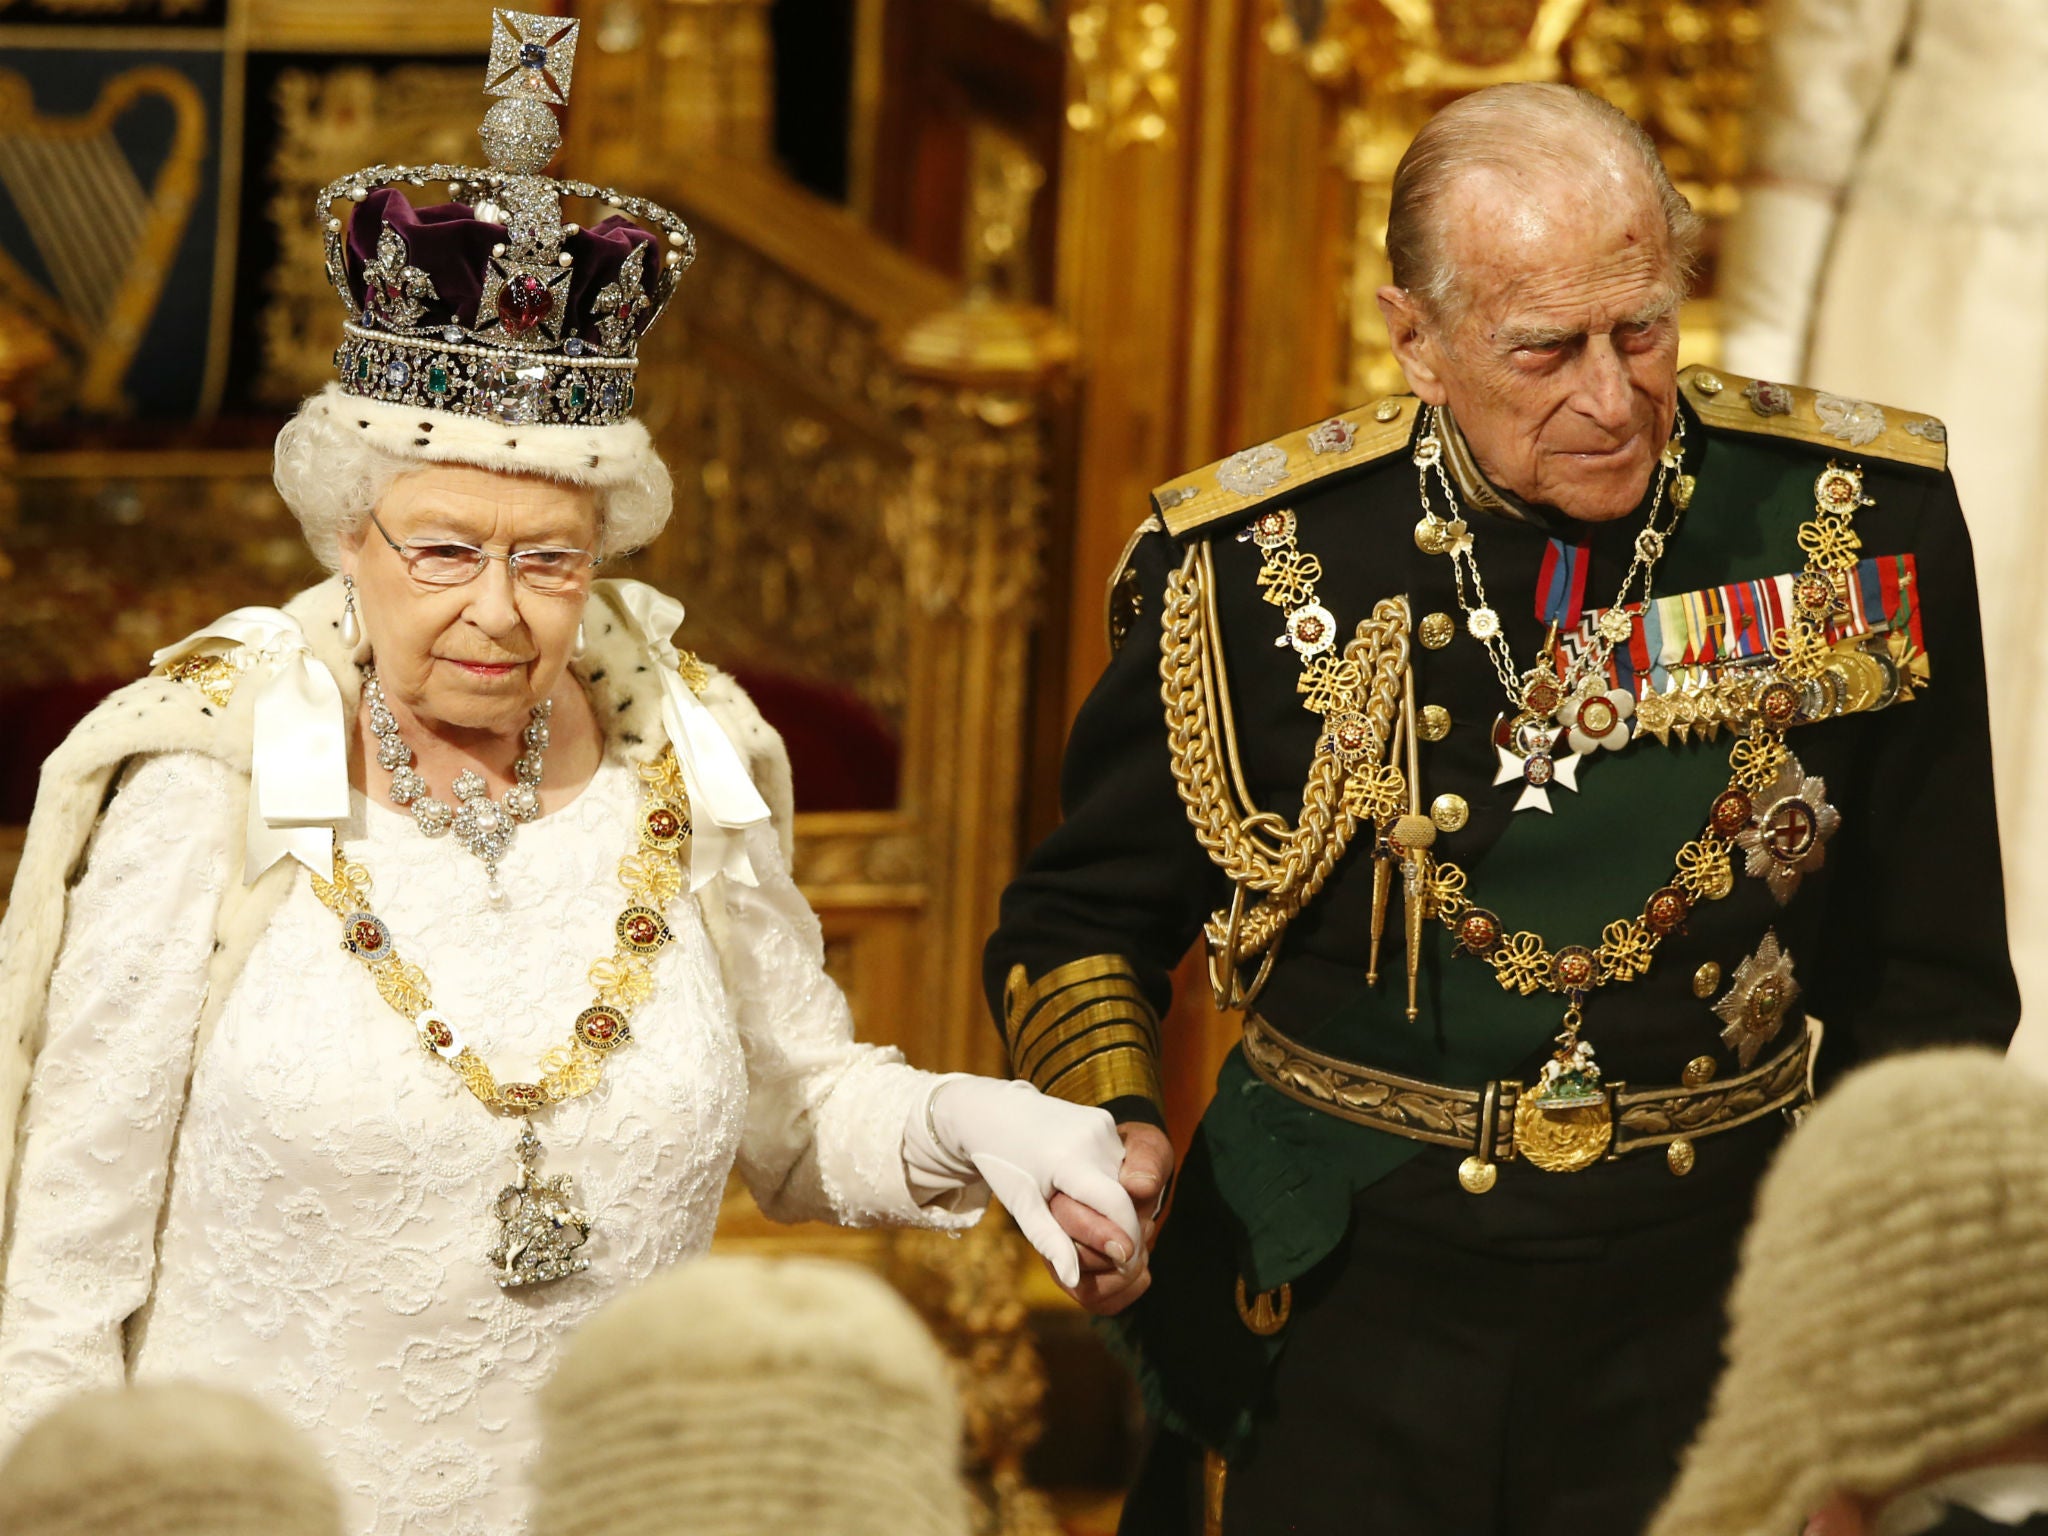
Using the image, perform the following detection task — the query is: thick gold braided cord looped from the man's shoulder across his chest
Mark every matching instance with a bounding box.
[1159,543,1409,1006]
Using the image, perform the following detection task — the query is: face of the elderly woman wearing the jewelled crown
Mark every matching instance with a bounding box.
[342,465,598,733]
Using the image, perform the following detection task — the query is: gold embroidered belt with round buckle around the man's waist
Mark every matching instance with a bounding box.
[1245,1014,1819,1194]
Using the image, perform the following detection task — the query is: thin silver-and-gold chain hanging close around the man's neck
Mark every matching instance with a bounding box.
[1415,406,1694,745]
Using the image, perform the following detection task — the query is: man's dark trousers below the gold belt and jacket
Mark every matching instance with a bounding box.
[1120,1159,1749,1536]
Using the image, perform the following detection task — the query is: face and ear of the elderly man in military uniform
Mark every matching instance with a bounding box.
[1380,174,1681,522]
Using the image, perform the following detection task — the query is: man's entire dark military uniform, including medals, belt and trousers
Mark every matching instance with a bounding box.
[987,369,2019,1534]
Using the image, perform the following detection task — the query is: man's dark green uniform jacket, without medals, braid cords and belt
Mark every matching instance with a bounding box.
[985,371,2019,1446]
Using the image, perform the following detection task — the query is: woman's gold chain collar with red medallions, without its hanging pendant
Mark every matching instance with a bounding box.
[313,748,690,1114]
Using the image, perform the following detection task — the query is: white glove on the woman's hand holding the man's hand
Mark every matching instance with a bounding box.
[926,1077,1141,1290]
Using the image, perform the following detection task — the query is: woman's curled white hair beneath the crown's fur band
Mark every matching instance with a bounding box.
[270,397,670,571]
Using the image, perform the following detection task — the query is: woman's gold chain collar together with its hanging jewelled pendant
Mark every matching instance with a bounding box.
[313,748,690,1290]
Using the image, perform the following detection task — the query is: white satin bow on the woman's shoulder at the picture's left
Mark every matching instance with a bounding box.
[150,608,348,885]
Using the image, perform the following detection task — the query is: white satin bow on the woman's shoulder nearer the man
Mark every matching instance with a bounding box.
[612,582,768,891]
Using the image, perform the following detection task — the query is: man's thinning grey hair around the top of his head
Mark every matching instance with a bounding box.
[1386,82,1704,319]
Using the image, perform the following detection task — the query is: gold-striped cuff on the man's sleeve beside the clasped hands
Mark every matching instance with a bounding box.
[1004,954,1163,1104]
